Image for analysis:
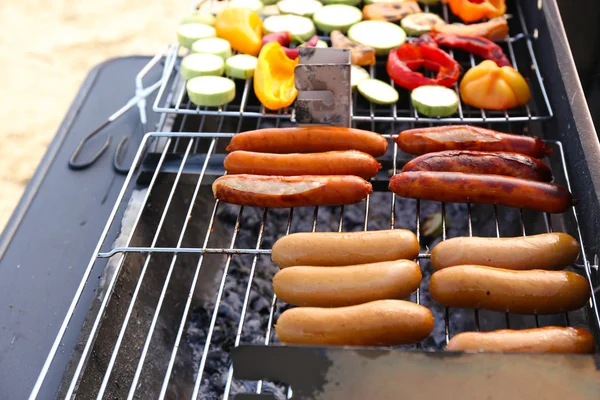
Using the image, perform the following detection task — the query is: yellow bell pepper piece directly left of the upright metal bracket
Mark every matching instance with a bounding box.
[254,42,298,110]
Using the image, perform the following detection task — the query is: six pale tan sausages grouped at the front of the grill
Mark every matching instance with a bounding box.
[272,229,594,353]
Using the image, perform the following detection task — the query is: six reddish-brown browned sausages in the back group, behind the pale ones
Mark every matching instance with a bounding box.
[213,125,573,213]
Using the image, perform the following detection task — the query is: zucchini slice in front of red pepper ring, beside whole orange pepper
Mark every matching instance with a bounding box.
[410,85,458,117]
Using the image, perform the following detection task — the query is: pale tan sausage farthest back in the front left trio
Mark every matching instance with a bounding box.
[271,229,419,268]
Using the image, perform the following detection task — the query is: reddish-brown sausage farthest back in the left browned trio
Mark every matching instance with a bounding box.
[227,126,387,157]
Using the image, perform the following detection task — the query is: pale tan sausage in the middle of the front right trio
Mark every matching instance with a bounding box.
[429,265,590,314]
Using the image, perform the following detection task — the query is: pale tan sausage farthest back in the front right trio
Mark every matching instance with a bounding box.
[431,232,579,270]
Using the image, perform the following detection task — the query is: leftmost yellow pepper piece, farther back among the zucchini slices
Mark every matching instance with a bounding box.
[215,7,262,56]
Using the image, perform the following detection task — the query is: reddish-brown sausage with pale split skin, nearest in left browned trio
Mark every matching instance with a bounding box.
[213,175,373,208]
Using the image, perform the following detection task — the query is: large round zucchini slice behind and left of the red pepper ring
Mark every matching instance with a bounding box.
[348,21,406,55]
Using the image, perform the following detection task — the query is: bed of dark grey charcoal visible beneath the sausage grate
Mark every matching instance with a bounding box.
[187,192,520,399]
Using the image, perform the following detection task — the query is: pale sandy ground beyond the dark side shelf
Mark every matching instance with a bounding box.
[0,0,191,231]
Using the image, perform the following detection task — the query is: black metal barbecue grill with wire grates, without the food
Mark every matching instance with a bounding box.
[25,0,600,399]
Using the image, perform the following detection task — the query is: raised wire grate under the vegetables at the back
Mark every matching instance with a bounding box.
[154,1,552,123]
